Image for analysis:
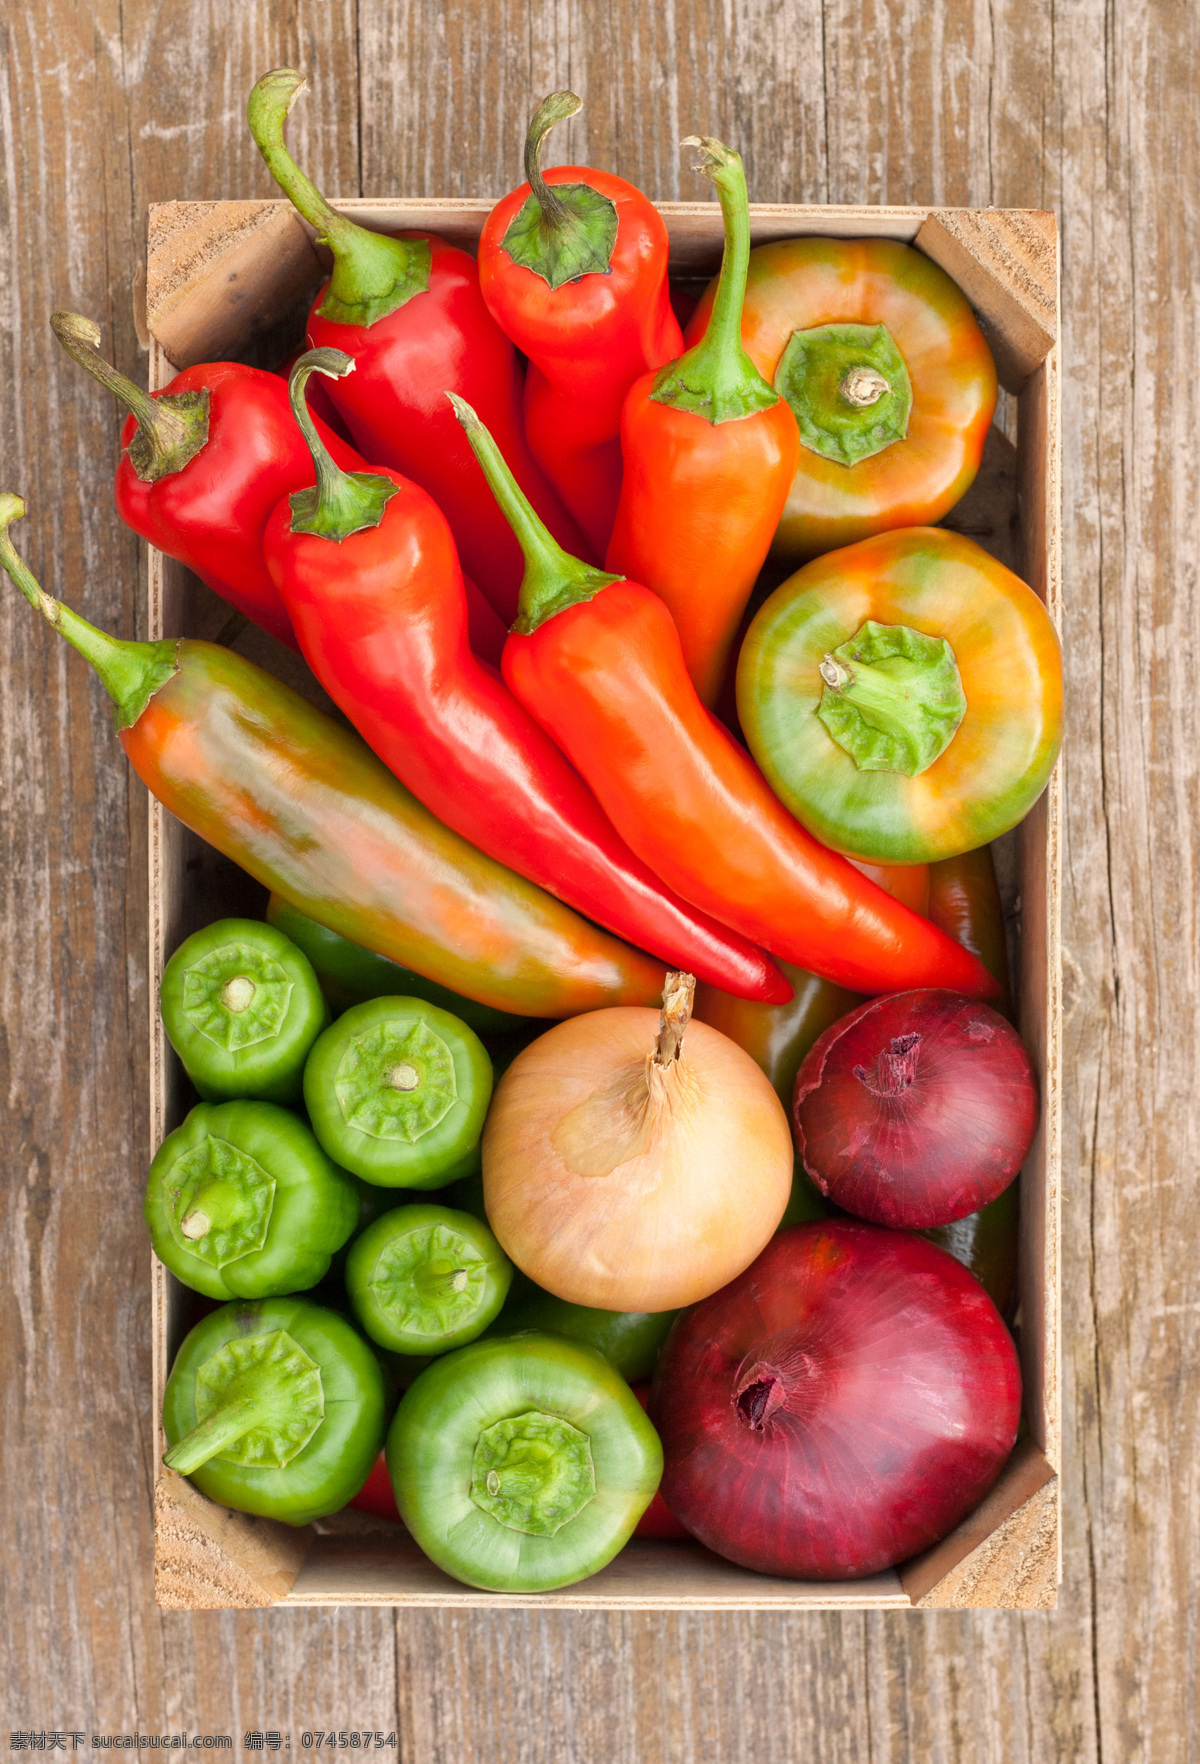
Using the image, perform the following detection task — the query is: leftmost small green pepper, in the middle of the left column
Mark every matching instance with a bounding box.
[145,1101,358,1298]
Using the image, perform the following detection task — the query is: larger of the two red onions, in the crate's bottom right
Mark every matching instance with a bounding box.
[649,1219,1020,1581]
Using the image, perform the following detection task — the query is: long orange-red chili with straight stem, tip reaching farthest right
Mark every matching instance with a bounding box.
[455,399,997,998]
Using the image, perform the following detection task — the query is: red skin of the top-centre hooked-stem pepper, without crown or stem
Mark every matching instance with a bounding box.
[478,166,683,557]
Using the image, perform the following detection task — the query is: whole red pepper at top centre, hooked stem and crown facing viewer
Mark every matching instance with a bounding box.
[478,92,683,557]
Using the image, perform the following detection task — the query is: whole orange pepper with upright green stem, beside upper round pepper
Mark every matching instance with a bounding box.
[605,136,799,706]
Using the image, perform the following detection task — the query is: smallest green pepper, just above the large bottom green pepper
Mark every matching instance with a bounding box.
[346,1201,512,1355]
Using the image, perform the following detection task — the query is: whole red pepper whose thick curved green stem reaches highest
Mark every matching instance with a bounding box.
[249,67,588,624]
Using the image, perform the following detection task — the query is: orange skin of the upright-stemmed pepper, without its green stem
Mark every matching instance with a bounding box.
[604,374,799,707]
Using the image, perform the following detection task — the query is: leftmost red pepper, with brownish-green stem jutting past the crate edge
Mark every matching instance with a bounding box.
[49,312,358,649]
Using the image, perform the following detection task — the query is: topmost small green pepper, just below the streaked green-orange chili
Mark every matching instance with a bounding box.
[159,919,330,1103]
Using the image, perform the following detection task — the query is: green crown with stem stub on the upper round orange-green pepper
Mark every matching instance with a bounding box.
[775,325,912,466]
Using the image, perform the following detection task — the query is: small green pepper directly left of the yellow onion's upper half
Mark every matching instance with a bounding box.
[304,998,492,1189]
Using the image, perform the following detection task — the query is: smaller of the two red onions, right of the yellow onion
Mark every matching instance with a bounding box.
[792,990,1038,1231]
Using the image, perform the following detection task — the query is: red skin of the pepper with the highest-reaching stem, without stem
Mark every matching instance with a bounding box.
[307,233,596,624]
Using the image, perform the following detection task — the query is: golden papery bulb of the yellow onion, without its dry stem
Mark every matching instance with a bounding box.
[482,1007,792,1311]
